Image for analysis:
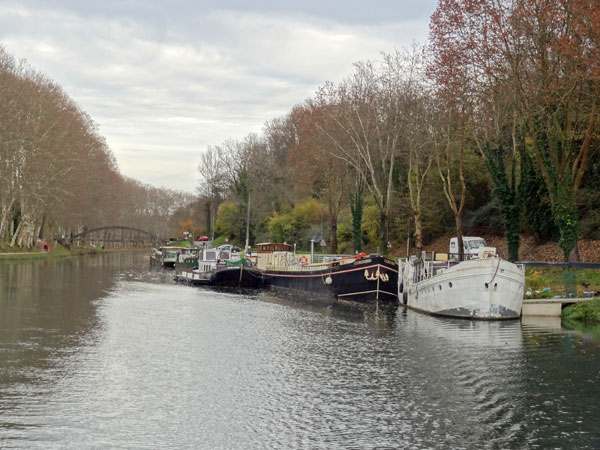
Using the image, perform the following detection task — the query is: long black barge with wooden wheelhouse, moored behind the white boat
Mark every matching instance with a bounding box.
[257,243,398,304]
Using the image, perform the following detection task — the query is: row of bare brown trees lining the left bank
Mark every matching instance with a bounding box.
[0,47,191,248]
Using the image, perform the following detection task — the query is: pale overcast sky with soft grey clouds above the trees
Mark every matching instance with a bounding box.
[0,0,436,192]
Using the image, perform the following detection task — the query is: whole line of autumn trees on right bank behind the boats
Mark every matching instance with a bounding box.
[199,0,600,259]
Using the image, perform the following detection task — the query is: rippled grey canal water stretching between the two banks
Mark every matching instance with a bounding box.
[0,254,600,449]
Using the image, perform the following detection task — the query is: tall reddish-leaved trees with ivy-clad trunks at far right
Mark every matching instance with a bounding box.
[429,0,600,258]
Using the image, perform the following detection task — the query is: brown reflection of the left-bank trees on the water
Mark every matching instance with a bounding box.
[0,258,114,385]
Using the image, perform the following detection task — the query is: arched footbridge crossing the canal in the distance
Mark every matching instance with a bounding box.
[56,225,165,248]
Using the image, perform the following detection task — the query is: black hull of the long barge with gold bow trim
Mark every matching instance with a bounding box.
[263,256,398,303]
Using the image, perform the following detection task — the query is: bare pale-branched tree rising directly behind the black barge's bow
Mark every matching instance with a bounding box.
[316,52,411,252]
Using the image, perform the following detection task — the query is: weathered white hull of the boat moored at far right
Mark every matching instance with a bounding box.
[399,258,525,320]
